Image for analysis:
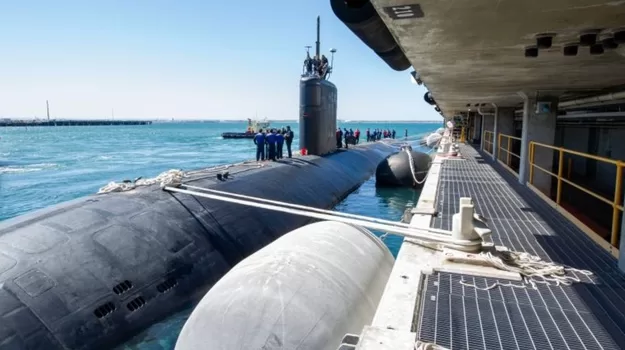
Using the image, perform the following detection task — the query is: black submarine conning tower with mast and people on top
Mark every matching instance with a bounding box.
[299,16,337,155]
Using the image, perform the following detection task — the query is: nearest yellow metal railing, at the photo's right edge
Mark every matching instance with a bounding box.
[529,141,625,249]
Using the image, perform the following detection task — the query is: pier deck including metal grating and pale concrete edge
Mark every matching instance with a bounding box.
[358,145,625,350]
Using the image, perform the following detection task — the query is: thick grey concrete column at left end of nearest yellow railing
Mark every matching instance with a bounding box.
[519,95,558,191]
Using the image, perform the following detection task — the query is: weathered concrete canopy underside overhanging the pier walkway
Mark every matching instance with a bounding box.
[371,0,625,116]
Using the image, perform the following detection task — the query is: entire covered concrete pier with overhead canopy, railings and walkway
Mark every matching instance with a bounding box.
[330,0,625,344]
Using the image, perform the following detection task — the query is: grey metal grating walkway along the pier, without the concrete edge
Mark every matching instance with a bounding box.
[418,145,625,350]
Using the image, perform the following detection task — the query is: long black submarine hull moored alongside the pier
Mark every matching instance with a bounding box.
[0,143,394,350]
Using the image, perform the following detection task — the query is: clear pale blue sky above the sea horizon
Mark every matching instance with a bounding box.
[0,0,440,120]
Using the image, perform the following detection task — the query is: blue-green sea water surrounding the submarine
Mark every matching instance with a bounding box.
[0,122,440,350]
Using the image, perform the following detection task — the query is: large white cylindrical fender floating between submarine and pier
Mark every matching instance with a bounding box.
[176,221,394,350]
